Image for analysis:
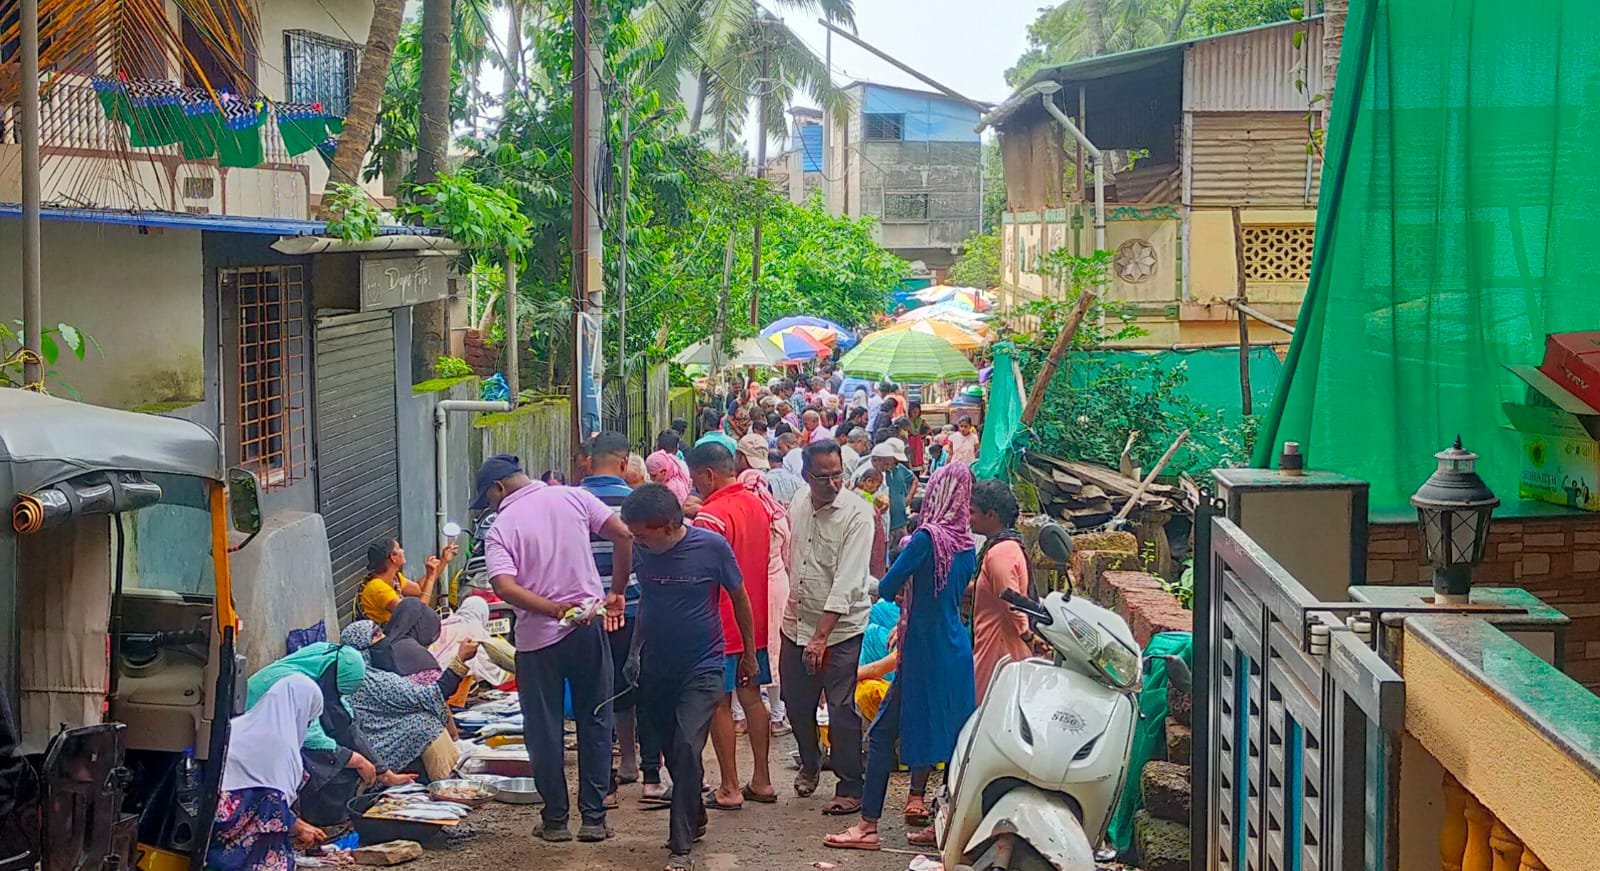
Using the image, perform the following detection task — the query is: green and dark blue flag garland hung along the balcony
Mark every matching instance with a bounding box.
[90,75,344,168]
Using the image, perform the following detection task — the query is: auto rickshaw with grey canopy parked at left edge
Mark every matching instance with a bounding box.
[0,389,262,871]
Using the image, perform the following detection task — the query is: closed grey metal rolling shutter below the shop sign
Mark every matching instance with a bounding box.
[317,312,400,620]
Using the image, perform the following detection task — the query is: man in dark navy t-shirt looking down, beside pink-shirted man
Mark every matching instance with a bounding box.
[622,484,757,868]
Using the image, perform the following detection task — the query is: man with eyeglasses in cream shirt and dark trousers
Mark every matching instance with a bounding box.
[778,440,874,815]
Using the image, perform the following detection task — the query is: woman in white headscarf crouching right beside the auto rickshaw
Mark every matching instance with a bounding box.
[205,674,325,871]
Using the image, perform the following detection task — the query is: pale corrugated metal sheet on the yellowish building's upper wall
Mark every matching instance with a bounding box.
[1184,21,1323,112]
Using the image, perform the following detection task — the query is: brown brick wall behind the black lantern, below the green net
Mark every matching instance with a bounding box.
[1366,516,1600,692]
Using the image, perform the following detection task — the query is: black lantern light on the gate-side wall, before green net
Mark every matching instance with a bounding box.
[1411,436,1499,605]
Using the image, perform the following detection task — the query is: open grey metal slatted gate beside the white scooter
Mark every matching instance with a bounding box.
[1194,500,1405,871]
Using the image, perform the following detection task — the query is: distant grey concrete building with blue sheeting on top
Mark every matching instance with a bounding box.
[822,82,984,279]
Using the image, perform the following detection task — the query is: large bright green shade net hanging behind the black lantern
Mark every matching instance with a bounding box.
[1254,0,1600,514]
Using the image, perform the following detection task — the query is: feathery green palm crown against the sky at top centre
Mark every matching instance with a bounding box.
[638,0,856,141]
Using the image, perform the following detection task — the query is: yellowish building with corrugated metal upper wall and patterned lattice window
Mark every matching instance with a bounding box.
[984,16,1339,344]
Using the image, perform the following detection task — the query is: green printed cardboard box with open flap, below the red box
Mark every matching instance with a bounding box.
[1501,367,1600,511]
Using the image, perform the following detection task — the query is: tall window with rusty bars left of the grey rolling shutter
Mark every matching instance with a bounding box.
[228,266,309,490]
